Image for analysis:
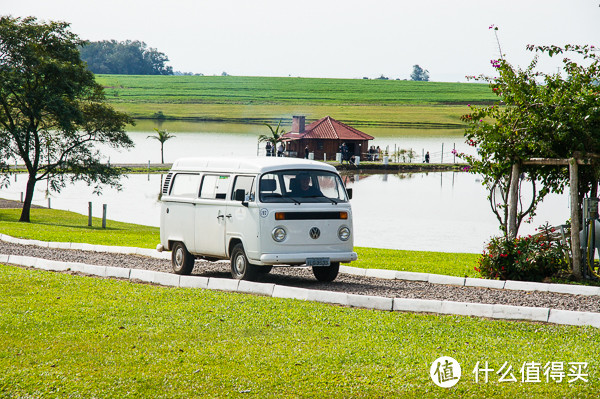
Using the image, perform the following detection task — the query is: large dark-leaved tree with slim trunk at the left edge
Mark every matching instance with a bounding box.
[0,16,133,222]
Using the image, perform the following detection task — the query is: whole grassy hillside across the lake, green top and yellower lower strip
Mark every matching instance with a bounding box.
[96,75,496,129]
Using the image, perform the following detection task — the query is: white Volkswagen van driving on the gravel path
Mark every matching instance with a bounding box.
[158,157,357,281]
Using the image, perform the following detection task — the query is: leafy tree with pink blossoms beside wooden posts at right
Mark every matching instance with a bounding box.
[463,45,600,241]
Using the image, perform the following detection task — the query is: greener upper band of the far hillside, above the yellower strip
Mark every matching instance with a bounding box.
[97,75,495,105]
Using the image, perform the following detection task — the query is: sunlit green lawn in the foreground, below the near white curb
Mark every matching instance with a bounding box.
[0,265,600,398]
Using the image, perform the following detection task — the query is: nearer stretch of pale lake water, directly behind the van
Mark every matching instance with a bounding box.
[0,172,569,253]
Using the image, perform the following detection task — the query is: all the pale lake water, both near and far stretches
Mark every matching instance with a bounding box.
[0,121,570,253]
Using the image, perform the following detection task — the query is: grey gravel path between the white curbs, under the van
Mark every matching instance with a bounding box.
[0,241,600,312]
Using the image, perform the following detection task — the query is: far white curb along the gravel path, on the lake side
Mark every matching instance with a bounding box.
[0,234,600,296]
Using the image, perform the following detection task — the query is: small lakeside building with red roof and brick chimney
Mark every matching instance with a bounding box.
[283,116,374,160]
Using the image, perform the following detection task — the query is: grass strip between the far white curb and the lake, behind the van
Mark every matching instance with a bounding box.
[0,209,477,277]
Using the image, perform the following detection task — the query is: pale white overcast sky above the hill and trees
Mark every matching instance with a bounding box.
[0,0,600,82]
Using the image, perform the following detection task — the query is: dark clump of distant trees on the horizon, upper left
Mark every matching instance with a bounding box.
[81,40,173,75]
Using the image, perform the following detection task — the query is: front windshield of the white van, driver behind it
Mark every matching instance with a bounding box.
[259,170,348,204]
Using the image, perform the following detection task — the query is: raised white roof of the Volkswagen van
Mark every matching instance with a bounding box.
[171,157,337,173]
